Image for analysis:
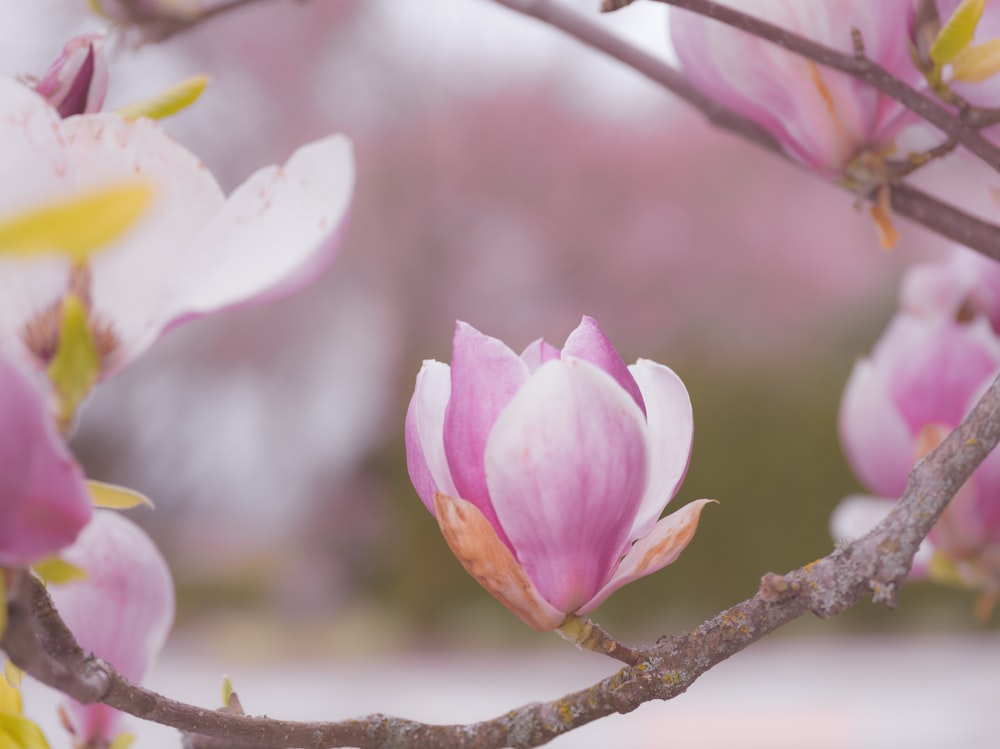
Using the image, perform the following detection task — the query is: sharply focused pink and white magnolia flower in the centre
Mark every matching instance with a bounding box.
[406,317,709,631]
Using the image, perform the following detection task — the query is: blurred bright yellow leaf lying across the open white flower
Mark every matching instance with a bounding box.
[0,182,153,262]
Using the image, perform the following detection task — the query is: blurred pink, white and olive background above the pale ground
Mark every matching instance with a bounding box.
[0,0,998,746]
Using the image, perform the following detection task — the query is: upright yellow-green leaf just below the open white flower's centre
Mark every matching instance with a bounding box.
[48,294,101,430]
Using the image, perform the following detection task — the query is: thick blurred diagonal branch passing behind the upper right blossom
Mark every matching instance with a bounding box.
[495,0,1000,261]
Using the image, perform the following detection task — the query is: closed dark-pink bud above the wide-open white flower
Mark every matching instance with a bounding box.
[35,34,108,117]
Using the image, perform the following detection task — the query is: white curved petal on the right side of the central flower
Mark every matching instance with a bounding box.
[629,359,694,540]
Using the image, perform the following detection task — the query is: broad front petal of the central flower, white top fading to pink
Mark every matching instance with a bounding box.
[485,358,648,613]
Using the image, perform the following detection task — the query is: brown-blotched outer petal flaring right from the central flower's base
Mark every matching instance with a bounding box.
[577,499,715,616]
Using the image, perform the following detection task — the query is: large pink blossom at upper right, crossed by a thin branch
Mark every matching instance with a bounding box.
[670,0,921,177]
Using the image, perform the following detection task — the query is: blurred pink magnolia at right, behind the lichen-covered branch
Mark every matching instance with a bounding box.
[834,314,1000,592]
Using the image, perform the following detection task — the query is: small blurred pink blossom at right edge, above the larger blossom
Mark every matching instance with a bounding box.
[900,247,1000,334]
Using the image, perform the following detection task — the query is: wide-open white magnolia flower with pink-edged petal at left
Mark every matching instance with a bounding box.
[0,78,354,375]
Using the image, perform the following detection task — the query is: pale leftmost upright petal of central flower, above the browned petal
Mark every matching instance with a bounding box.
[406,361,458,514]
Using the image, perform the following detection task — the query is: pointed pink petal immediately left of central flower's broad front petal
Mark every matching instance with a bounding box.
[444,322,528,541]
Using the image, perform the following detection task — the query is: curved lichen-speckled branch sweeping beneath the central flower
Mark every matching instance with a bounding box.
[7,377,1000,749]
